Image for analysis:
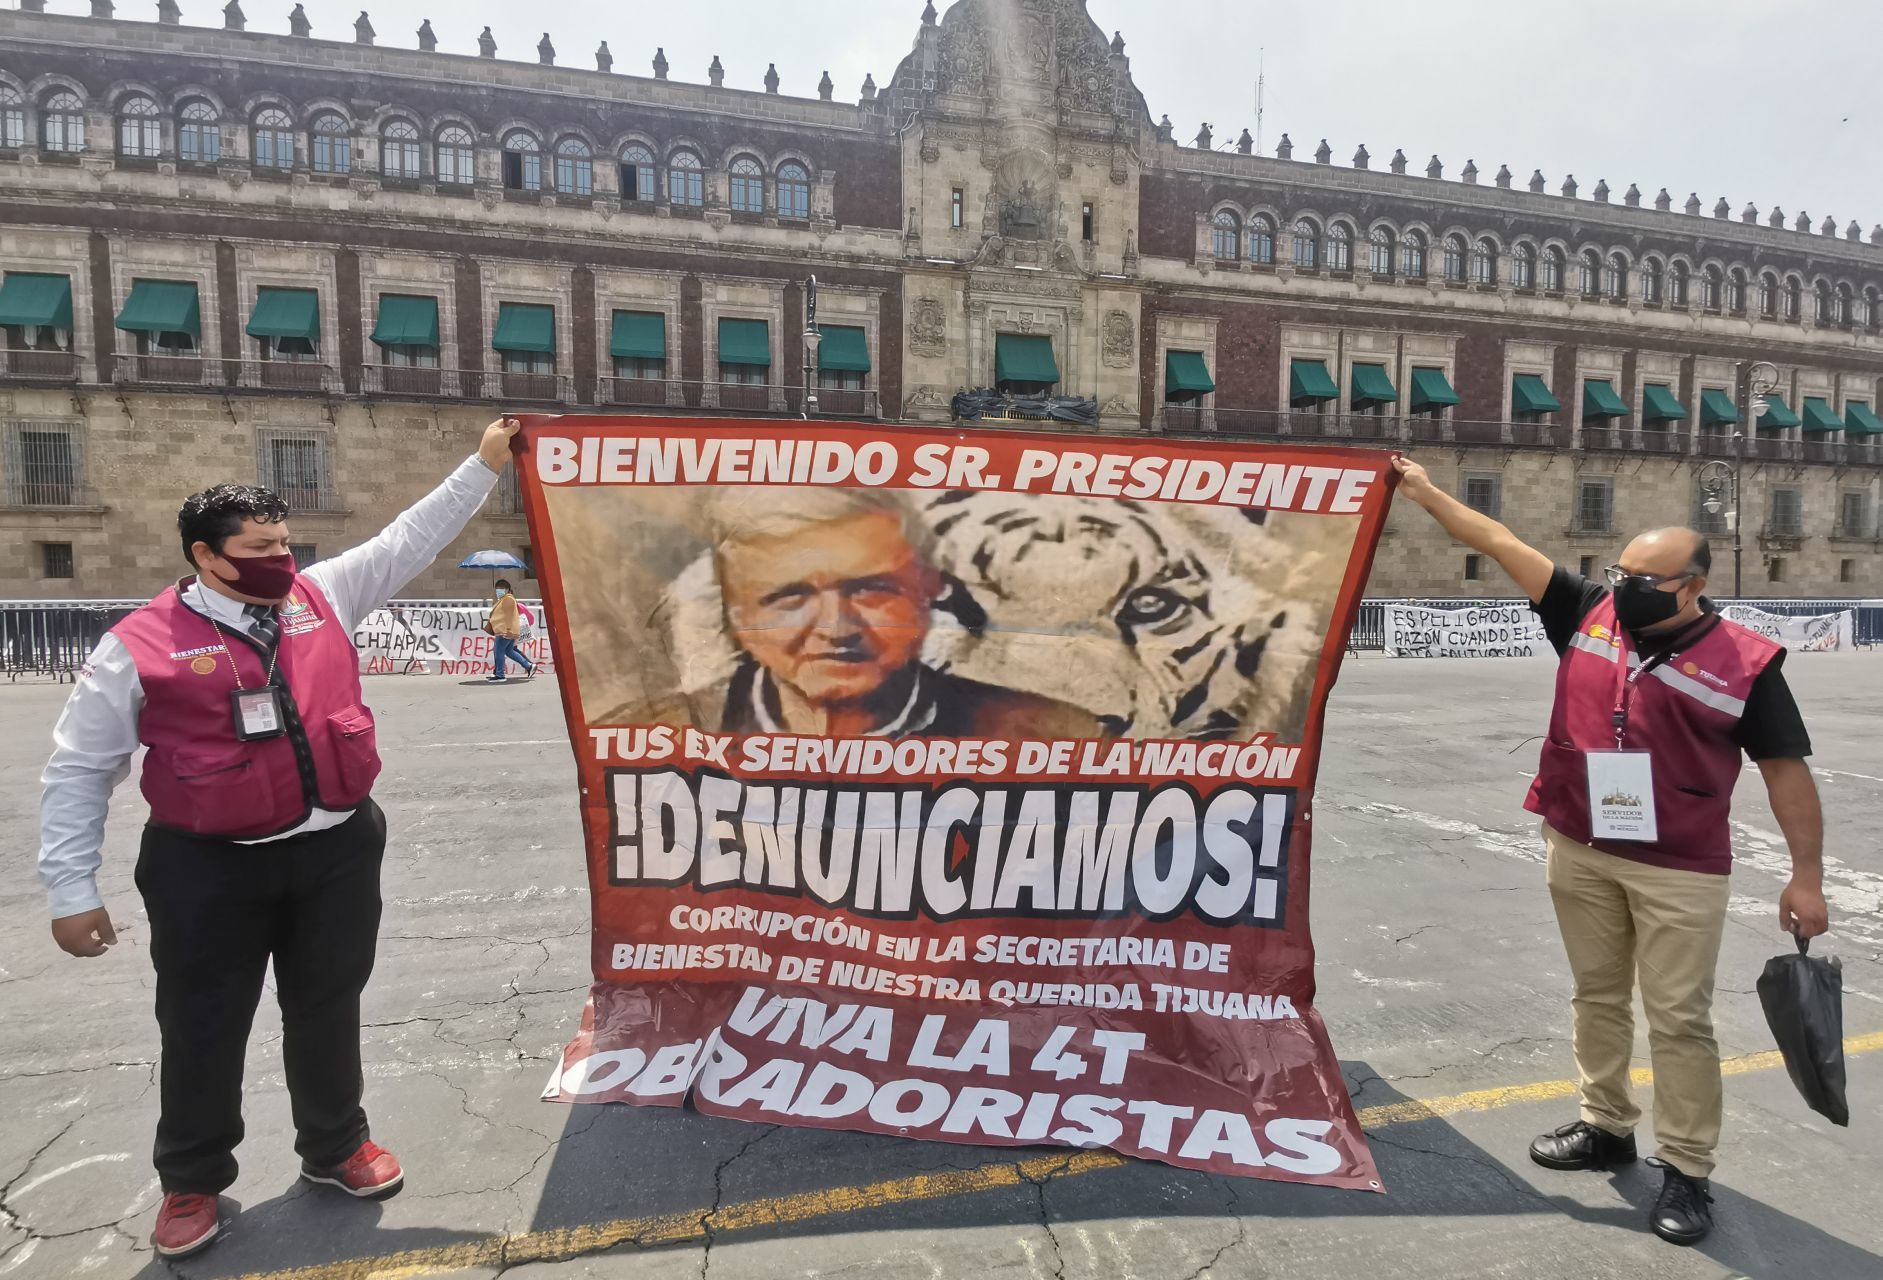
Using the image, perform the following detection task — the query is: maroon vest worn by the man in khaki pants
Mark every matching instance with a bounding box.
[1523,597,1779,875]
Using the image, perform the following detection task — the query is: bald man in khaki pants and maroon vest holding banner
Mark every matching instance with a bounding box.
[1393,457,1830,1244]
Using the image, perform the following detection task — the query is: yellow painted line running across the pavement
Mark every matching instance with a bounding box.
[239,1032,1883,1280]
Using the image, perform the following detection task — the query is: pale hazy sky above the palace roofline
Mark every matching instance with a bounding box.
[14,0,1883,237]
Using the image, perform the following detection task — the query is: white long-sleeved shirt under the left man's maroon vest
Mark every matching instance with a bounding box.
[40,454,497,920]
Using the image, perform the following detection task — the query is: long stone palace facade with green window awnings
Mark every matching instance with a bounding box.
[0,0,1883,599]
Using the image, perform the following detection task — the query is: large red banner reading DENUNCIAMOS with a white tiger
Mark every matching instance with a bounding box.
[516,416,1392,1190]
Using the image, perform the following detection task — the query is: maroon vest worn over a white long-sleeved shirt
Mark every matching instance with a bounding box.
[111,576,378,840]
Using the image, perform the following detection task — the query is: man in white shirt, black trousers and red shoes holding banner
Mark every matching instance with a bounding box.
[40,420,516,1257]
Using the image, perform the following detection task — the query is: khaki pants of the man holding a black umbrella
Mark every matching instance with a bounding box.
[1542,823,1730,1178]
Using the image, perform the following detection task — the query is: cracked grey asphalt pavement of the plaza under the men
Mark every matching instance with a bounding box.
[0,653,1883,1280]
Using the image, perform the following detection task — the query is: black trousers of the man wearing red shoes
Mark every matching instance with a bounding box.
[137,800,386,1195]
